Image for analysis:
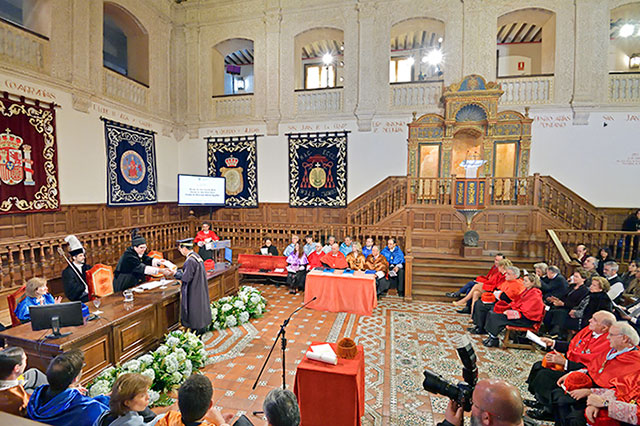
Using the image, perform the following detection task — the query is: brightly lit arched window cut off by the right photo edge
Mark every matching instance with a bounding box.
[609,2,640,72]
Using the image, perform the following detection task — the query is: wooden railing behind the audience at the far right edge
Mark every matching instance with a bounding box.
[545,229,640,276]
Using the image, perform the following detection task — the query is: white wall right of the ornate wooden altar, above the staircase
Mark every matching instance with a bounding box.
[529,110,640,207]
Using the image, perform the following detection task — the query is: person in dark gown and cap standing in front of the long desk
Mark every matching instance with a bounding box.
[170,238,211,335]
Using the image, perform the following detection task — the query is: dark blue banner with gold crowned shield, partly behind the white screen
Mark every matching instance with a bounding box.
[206,135,259,207]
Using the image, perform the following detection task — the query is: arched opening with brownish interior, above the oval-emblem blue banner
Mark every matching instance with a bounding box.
[102,2,149,85]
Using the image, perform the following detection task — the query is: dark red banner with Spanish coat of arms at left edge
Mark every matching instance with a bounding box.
[0,92,60,214]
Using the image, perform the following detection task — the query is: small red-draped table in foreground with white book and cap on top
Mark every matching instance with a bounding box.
[293,342,364,426]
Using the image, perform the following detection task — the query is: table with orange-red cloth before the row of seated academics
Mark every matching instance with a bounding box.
[304,271,378,315]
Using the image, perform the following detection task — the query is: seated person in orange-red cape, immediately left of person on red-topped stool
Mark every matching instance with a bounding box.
[467,259,524,334]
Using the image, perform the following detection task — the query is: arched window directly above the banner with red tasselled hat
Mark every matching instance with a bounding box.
[294,28,344,89]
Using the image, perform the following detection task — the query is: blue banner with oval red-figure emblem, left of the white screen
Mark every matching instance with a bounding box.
[101,118,158,206]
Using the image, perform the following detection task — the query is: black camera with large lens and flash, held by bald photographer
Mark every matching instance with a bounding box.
[422,336,478,411]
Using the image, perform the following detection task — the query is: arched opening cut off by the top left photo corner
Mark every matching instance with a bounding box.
[0,0,51,38]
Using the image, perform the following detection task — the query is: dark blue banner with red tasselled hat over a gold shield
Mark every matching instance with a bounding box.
[287,132,349,207]
